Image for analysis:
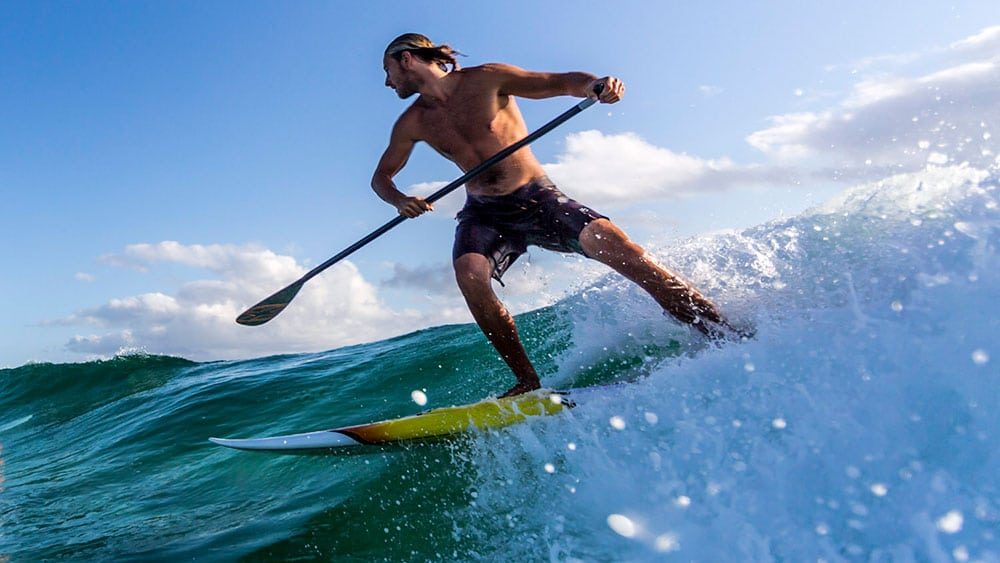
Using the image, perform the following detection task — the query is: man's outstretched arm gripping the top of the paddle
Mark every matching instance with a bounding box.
[483,63,625,104]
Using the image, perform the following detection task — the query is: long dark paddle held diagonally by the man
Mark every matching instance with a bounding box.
[236,84,604,326]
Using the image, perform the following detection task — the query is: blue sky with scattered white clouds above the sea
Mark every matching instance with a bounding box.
[0,1,1000,367]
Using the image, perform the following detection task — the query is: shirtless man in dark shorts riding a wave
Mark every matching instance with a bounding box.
[372,33,733,396]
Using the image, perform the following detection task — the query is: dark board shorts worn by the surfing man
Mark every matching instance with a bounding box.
[451,176,607,285]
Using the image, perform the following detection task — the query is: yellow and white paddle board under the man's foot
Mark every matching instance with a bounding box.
[209,385,614,451]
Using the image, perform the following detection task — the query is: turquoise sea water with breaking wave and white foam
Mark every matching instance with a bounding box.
[0,167,1000,561]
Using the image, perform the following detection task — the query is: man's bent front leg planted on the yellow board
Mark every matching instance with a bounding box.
[454,253,541,397]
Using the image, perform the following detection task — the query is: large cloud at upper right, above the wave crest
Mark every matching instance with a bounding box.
[746,27,1000,174]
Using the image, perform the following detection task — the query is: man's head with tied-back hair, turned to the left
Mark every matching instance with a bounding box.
[382,33,460,98]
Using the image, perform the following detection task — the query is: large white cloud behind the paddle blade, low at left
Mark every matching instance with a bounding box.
[58,241,458,360]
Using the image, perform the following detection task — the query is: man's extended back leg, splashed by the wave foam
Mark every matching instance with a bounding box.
[580,219,732,337]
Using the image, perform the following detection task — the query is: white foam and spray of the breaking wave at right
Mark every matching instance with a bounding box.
[461,166,1000,561]
